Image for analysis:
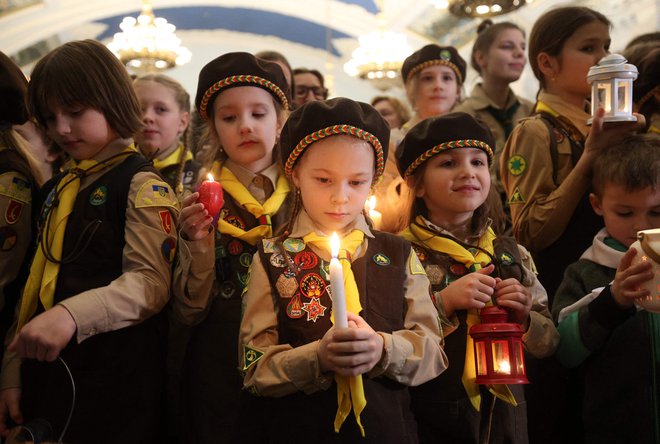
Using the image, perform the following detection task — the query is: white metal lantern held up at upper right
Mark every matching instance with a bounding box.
[587,54,638,125]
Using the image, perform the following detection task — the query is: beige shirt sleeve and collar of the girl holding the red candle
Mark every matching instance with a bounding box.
[172,159,280,325]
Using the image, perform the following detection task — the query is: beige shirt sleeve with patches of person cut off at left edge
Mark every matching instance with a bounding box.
[0,147,36,360]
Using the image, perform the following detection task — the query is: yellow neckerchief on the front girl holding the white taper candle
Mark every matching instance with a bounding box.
[303,230,367,437]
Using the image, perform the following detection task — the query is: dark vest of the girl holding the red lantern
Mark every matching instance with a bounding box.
[411,236,527,444]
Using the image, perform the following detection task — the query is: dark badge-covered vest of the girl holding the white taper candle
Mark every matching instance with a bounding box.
[259,232,417,443]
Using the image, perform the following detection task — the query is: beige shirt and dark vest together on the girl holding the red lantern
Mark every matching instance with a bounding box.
[411,219,559,443]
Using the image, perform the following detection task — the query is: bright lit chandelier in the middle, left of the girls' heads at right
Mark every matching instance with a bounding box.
[344,1,412,91]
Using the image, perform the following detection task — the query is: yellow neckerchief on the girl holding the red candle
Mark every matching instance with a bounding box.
[212,161,290,245]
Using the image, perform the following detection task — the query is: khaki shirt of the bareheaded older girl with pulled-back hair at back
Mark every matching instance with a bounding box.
[452,83,534,193]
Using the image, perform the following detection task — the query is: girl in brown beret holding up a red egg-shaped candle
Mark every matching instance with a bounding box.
[173,52,291,443]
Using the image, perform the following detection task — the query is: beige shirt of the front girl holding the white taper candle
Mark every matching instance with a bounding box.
[239,210,447,397]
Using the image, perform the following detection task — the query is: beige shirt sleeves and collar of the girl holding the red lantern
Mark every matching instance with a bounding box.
[424,218,559,358]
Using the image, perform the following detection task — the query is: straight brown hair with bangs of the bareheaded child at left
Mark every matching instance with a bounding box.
[27,40,142,138]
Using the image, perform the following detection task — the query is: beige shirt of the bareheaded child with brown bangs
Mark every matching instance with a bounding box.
[0,139,179,389]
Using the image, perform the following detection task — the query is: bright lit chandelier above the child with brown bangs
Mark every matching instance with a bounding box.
[108,0,192,74]
